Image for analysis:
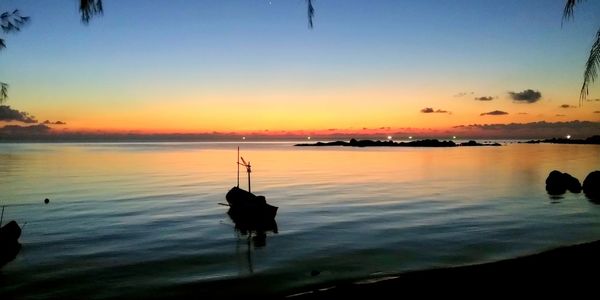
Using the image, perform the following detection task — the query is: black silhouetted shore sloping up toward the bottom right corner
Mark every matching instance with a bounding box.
[288,241,600,299]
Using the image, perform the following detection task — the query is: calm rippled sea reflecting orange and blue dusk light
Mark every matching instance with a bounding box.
[0,143,600,299]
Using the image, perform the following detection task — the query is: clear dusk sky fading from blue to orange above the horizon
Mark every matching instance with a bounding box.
[0,0,600,136]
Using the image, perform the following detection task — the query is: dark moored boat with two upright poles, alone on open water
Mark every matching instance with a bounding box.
[225,147,278,225]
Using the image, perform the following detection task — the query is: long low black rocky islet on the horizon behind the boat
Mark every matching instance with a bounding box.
[294,139,501,147]
